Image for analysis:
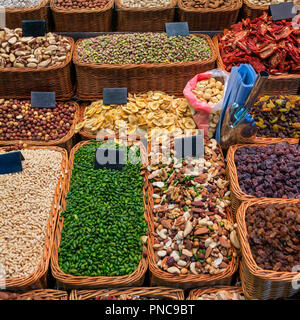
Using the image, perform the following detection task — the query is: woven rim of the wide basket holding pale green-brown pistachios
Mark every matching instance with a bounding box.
[73,31,217,70]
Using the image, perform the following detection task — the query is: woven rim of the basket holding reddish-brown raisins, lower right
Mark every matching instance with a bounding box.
[236,199,300,282]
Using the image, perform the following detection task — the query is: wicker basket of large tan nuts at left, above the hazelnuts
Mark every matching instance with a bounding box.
[0,37,74,100]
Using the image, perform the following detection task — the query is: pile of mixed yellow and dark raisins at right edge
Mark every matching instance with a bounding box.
[251,96,300,138]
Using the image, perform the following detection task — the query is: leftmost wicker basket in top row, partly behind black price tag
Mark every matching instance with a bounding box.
[5,0,49,29]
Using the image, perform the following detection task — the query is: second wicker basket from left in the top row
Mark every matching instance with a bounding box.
[50,0,114,32]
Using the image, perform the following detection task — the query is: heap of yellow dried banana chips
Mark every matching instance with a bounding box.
[76,91,196,138]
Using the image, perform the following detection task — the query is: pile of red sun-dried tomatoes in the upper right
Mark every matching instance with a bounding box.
[219,13,300,75]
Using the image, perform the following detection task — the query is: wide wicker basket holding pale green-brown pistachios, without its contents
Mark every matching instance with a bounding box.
[73,34,216,101]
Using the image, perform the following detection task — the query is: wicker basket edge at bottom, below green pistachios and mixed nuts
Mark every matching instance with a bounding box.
[70,287,184,300]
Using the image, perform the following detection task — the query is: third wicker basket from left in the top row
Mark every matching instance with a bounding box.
[115,0,177,32]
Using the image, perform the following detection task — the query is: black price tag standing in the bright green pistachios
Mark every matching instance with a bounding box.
[94,148,125,170]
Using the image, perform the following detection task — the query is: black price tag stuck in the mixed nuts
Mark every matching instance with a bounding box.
[174,130,204,159]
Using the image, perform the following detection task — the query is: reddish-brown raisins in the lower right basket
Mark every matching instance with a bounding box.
[246,202,300,272]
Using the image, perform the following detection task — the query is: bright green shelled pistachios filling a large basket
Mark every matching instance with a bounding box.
[58,140,148,277]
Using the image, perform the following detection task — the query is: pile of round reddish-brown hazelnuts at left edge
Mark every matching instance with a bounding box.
[0,99,75,141]
